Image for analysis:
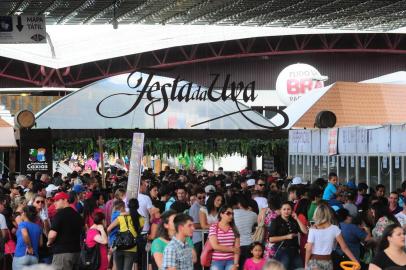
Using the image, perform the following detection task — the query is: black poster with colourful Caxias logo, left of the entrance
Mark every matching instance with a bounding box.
[20,129,52,177]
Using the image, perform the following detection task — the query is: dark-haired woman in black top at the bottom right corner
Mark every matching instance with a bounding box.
[369,224,406,270]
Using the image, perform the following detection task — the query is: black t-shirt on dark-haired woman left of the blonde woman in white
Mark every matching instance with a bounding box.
[269,216,301,248]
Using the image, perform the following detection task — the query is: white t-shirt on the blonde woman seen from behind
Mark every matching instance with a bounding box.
[307,225,341,255]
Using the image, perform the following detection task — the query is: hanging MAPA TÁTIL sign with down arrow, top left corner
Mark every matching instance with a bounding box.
[0,15,46,44]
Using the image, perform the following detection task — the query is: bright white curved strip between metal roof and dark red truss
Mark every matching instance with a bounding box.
[0,24,405,68]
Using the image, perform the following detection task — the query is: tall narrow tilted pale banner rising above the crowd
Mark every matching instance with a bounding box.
[127,133,144,200]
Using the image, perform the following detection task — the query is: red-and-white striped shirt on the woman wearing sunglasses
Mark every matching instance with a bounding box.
[209,223,235,261]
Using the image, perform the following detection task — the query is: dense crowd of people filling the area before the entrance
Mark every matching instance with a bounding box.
[0,167,406,270]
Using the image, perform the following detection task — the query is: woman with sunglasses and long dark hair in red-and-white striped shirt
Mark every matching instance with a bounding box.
[209,206,240,270]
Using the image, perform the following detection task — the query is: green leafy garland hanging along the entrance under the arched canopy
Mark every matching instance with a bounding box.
[53,138,288,158]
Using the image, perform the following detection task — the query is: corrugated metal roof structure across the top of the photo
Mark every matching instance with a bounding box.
[0,0,406,31]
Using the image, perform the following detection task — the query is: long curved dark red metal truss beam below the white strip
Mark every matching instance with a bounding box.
[0,33,406,87]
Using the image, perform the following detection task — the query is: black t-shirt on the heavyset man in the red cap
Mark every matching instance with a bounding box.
[51,207,84,254]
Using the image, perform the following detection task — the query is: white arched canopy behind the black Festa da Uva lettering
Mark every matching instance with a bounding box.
[36,72,273,130]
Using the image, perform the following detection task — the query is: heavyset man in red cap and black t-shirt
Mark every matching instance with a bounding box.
[47,192,84,270]
